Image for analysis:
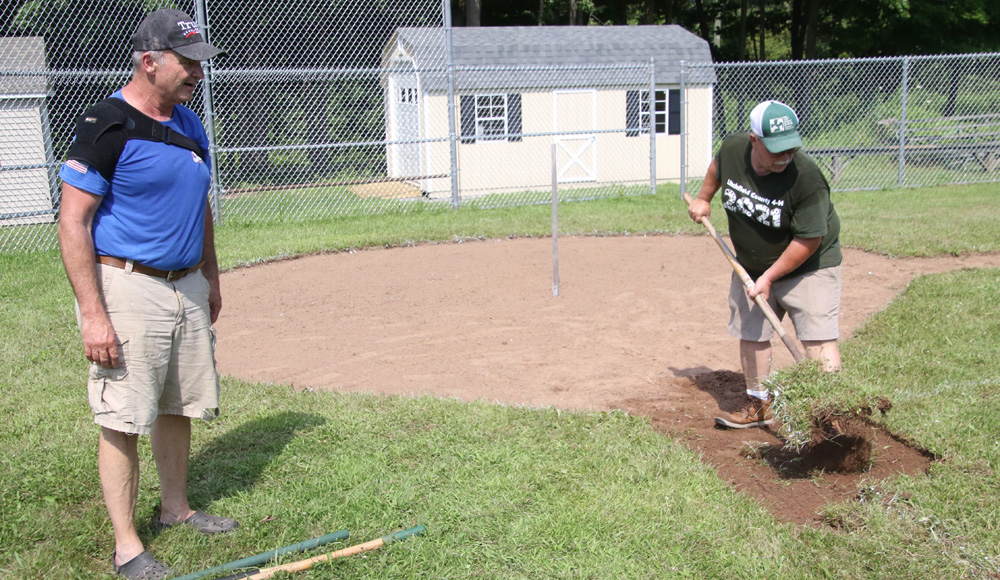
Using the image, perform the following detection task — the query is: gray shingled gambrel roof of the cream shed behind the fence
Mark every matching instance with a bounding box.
[387,25,716,91]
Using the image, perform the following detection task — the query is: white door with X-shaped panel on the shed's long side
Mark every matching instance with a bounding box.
[552,89,597,183]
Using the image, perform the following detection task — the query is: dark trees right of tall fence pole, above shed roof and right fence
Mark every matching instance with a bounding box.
[451,0,1000,62]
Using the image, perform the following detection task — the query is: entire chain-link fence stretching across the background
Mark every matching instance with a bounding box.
[0,0,1000,252]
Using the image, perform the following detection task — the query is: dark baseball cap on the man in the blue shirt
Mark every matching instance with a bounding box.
[132,8,226,60]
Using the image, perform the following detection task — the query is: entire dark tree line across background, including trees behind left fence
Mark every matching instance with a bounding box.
[0,0,1000,182]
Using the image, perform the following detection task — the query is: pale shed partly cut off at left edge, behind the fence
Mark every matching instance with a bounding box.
[0,36,56,226]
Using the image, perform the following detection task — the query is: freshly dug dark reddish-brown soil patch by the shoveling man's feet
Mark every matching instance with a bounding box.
[620,371,934,525]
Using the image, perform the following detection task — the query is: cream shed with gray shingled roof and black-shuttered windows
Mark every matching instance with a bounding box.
[383,25,716,195]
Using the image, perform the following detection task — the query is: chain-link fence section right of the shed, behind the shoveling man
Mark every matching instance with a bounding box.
[685,54,1000,192]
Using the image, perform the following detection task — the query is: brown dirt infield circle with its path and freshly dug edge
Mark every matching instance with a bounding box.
[217,236,1000,524]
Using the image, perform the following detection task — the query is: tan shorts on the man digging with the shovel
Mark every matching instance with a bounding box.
[729,266,840,342]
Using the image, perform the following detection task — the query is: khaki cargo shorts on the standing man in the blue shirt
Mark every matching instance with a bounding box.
[83,264,219,435]
